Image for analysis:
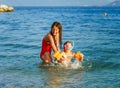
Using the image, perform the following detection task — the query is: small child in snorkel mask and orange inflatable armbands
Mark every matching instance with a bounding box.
[54,41,83,67]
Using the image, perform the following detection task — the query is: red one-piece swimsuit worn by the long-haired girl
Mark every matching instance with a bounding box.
[40,39,51,58]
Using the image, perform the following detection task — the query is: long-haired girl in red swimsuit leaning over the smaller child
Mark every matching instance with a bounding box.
[40,22,62,63]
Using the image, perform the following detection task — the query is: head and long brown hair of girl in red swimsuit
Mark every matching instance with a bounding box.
[50,21,62,44]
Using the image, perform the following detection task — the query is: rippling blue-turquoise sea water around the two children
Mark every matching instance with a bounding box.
[0,7,120,88]
